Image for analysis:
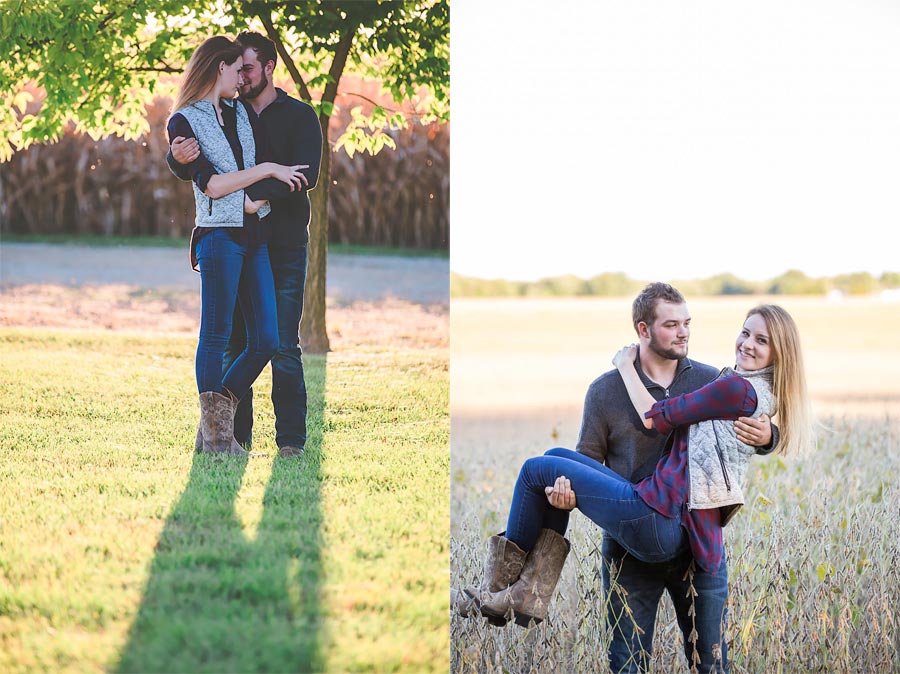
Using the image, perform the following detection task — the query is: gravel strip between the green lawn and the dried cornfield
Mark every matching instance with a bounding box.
[0,243,449,348]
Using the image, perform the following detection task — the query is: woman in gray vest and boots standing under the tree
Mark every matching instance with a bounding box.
[168,36,303,455]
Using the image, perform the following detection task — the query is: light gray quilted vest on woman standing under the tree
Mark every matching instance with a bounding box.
[178,99,272,227]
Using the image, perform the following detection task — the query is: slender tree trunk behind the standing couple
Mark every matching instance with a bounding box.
[300,115,331,353]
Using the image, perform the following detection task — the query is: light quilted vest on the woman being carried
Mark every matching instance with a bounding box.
[688,366,775,527]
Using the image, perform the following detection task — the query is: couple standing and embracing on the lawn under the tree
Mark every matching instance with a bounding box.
[166,32,322,458]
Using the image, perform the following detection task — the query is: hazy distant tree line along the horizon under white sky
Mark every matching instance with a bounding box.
[450,269,900,297]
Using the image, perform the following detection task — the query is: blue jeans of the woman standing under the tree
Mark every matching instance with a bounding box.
[196,227,278,398]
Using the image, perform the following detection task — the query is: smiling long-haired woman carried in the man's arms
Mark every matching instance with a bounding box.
[453,304,811,626]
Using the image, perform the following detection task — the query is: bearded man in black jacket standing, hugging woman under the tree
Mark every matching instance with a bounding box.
[166,32,322,458]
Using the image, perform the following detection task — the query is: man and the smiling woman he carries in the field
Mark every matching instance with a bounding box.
[451,283,811,674]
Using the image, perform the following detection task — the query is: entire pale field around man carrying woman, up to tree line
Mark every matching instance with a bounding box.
[451,297,900,674]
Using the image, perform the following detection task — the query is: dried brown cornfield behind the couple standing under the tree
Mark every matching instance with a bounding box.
[0,99,450,249]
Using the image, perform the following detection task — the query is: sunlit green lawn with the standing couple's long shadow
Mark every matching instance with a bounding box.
[0,328,450,672]
